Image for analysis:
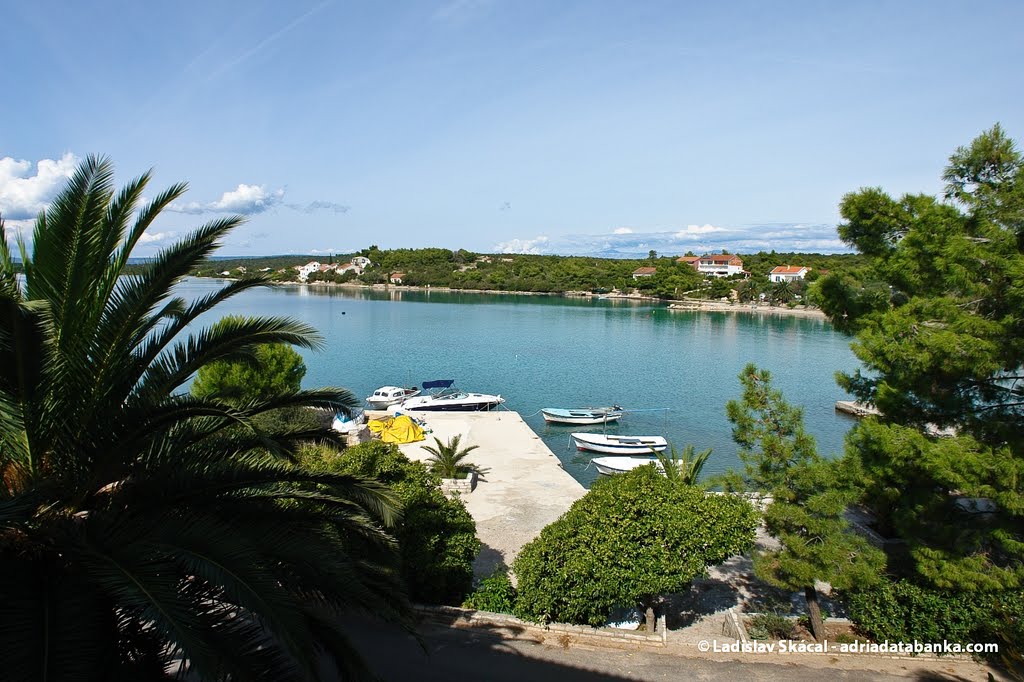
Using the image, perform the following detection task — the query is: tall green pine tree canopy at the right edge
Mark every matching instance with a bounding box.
[818,125,1024,590]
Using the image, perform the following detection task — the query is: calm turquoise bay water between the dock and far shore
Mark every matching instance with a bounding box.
[181,280,858,484]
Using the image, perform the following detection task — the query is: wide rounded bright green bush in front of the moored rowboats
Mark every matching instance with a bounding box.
[513,467,758,626]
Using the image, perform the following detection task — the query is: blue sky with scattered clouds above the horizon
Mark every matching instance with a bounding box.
[0,0,1024,256]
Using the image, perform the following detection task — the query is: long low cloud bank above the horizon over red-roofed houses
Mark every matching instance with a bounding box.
[494,223,851,258]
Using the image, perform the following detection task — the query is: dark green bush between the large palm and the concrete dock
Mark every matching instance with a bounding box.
[302,440,480,604]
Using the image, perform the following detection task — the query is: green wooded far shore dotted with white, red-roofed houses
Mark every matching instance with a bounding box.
[194,246,862,307]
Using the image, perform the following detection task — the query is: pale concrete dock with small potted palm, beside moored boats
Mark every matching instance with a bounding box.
[391,410,587,576]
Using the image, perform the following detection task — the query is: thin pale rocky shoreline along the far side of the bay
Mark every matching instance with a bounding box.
[191,275,828,321]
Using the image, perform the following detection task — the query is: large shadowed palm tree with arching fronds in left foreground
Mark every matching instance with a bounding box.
[0,158,406,681]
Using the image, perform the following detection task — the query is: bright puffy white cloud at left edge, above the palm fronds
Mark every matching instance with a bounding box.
[0,152,79,220]
